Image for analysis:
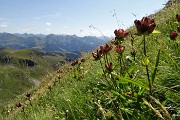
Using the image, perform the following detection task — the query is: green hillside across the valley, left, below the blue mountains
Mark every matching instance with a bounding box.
[0,48,64,105]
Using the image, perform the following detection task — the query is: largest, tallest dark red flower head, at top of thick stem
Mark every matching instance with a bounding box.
[134,17,156,35]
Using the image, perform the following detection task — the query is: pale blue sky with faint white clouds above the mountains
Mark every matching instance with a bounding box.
[0,0,168,36]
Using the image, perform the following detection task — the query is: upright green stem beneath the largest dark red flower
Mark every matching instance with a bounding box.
[143,35,152,94]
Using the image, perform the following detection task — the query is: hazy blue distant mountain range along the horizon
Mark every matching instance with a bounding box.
[0,33,110,52]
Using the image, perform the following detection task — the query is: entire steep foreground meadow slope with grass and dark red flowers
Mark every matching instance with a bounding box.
[0,0,180,120]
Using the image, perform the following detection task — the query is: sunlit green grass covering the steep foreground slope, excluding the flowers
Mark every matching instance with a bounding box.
[1,0,180,120]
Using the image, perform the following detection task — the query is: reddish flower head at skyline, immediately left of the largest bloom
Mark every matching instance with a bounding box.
[114,29,128,39]
